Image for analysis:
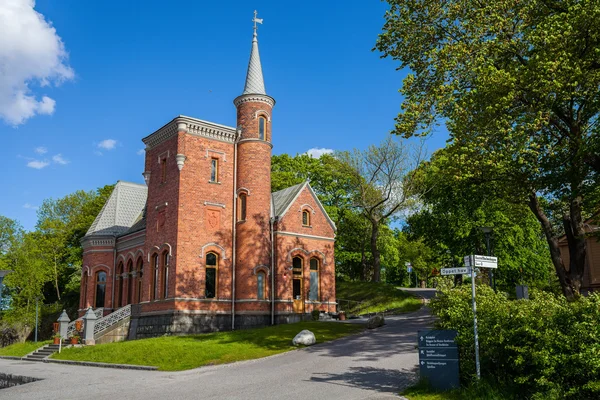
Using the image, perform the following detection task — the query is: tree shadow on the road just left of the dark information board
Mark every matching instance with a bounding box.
[310,367,417,394]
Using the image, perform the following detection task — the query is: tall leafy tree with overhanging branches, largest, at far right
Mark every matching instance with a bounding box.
[376,0,600,298]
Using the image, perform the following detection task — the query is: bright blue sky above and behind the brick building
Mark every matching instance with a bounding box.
[0,0,446,229]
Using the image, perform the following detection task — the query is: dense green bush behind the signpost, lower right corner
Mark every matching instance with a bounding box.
[431,286,600,399]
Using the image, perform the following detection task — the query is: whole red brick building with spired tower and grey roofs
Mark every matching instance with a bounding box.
[80,19,335,337]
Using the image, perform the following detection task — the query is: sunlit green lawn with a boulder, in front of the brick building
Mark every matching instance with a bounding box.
[52,321,364,371]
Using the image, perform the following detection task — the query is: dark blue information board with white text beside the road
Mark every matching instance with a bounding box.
[419,330,459,390]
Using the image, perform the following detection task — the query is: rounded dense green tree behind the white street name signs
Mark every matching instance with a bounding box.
[406,146,552,289]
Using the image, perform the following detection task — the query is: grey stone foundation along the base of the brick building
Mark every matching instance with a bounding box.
[128,311,311,339]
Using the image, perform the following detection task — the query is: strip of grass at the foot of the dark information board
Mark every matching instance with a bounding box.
[402,381,515,400]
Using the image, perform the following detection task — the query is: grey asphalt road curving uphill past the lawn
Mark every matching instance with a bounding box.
[0,289,434,400]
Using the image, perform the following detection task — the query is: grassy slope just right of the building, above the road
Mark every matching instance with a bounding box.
[336,282,421,314]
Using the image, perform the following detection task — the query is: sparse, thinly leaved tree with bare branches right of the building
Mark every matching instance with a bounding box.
[337,137,421,282]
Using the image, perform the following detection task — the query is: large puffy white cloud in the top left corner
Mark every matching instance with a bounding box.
[0,0,74,126]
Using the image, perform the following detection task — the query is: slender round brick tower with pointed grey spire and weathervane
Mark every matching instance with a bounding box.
[234,11,275,313]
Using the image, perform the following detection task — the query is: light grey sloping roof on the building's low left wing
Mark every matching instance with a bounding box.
[86,181,148,236]
